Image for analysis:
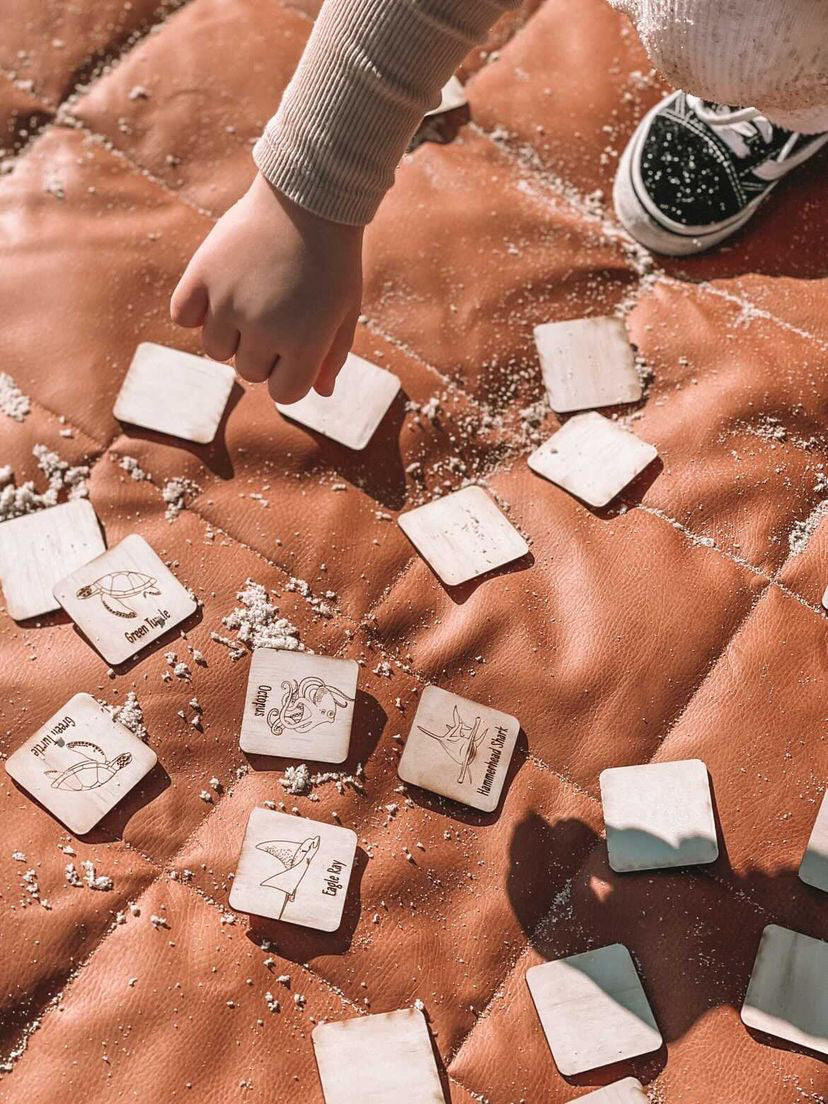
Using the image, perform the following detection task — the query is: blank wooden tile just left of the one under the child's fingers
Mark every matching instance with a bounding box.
[114,341,235,445]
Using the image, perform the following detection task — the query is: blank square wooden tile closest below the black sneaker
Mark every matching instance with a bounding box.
[534,318,641,414]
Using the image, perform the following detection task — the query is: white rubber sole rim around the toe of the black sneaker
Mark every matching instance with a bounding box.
[613,97,773,257]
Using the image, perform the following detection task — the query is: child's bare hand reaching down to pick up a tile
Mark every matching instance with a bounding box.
[170,167,363,403]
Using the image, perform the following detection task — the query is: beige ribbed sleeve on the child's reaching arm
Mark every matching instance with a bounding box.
[253,0,520,225]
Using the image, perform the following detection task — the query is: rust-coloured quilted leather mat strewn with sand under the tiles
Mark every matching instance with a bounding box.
[0,0,828,1104]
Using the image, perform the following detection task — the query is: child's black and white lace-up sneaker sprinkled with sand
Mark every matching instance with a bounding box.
[613,92,828,256]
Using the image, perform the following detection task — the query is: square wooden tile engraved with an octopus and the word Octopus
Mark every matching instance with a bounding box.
[240,648,359,763]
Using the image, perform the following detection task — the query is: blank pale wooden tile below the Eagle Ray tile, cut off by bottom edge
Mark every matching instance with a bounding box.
[312,1008,446,1104]
